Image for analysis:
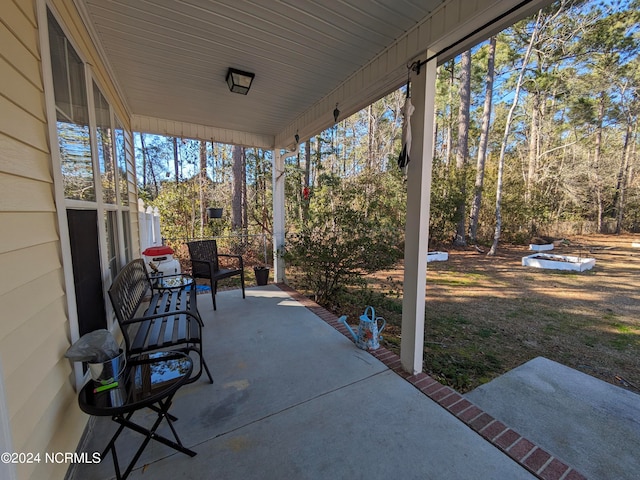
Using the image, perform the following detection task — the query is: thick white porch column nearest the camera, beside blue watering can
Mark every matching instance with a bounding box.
[400,58,437,374]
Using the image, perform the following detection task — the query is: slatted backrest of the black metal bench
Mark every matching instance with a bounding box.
[109,258,149,326]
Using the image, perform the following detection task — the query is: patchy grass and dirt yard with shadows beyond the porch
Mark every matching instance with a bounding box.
[356,235,640,393]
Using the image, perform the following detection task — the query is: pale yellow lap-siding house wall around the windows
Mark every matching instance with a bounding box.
[0,0,138,479]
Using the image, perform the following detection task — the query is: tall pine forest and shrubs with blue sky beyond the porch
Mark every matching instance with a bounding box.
[135,0,640,298]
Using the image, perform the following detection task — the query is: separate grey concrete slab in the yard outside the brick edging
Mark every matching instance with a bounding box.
[465,357,640,480]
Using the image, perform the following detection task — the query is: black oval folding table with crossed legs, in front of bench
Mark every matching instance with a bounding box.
[78,352,196,480]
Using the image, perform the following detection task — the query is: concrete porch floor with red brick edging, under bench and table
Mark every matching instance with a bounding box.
[68,285,585,480]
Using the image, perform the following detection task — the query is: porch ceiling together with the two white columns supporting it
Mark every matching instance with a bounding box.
[76,0,551,374]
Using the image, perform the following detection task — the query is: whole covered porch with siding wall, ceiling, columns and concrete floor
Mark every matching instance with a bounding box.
[0,0,624,479]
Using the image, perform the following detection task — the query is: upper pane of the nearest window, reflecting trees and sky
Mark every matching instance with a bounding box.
[48,12,96,201]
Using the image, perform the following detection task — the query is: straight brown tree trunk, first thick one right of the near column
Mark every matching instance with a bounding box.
[453,50,471,246]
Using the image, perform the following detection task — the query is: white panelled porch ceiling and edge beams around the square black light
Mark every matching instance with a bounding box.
[76,0,549,148]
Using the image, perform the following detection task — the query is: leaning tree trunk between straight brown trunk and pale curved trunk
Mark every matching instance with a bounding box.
[469,35,496,243]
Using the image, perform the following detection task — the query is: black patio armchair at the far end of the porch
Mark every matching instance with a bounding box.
[187,240,246,310]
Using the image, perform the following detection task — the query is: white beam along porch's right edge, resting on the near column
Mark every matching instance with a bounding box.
[275,0,551,148]
